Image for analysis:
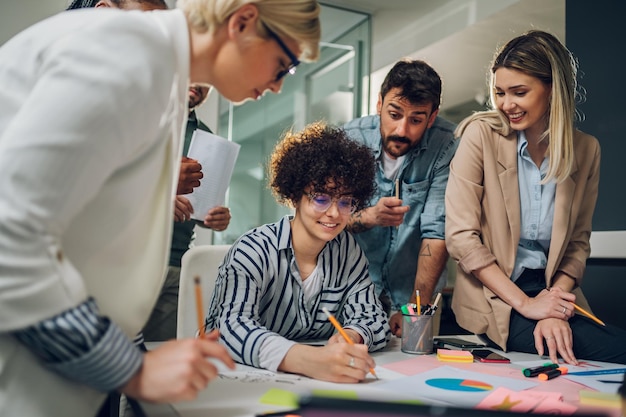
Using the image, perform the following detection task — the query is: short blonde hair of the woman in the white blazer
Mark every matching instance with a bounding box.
[176,0,321,62]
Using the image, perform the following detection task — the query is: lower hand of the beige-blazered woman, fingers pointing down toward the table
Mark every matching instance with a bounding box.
[533,318,578,365]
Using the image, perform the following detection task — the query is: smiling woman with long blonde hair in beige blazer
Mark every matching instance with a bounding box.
[446,31,626,364]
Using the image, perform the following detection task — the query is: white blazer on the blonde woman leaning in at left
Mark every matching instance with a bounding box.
[0,9,189,417]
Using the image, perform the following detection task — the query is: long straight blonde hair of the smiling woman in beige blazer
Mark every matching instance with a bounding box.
[455,30,578,183]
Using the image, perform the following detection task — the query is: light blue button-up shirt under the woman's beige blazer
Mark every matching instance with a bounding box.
[511,132,556,281]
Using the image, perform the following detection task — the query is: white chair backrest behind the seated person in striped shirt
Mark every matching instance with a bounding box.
[176,245,231,339]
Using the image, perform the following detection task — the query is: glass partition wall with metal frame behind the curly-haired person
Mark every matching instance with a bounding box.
[213,5,371,244]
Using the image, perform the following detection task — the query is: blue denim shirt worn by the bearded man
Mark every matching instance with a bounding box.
[344,115,458,310]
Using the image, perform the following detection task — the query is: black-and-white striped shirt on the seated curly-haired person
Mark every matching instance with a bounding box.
[206,216,391,371]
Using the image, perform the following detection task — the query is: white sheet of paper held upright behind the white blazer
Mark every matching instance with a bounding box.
[185,129,241,221]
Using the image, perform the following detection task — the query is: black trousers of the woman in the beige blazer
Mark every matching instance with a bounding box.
[507,269,626,364]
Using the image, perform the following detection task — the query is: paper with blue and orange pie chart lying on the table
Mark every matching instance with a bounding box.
[377,366,537,407]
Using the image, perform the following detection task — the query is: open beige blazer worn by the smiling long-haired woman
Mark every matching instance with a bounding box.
[446,120,600,349]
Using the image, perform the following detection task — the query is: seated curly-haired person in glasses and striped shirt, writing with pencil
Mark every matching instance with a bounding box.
[206,123,391,383]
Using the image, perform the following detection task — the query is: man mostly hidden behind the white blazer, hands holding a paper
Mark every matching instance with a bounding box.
[143,85,230,341]
